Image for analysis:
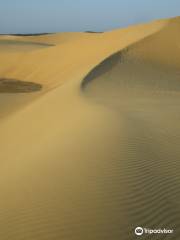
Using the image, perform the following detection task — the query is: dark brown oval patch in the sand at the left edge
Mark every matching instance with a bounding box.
[0,78,42,93]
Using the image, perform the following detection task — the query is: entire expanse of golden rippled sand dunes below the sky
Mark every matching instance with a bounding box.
[0,15,180,240]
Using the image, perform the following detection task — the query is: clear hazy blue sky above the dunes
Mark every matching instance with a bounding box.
[0,0,180,34]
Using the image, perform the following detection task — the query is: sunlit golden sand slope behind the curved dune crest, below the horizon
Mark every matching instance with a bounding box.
[0,20,168,116]
